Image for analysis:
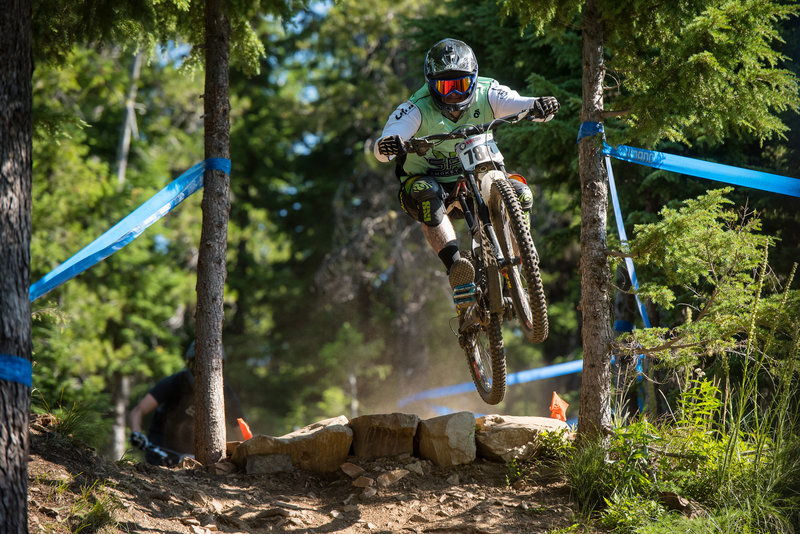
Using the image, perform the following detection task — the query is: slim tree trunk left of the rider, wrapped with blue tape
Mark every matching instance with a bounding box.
[194,0,231,465]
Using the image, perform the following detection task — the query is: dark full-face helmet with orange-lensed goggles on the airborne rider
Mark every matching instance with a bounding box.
[425,39,478,112]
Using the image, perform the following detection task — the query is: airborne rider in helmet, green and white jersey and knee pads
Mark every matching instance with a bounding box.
[373,39,560,322]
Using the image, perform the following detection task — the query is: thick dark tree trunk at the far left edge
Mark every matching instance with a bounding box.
[0,0,33,534]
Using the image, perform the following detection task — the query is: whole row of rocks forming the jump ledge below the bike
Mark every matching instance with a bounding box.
[228,412,568,476]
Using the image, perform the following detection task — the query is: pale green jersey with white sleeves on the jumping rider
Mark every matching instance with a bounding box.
[374,78,535,183]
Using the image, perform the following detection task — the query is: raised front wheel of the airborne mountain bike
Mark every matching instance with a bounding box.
[489,175,549,343]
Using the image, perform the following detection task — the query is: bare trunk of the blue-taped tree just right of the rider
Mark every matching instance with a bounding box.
[578,0,612,440]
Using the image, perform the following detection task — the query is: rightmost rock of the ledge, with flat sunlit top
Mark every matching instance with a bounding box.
[475,415,569,462]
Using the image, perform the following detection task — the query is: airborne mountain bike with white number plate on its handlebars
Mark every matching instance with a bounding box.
[405,110,548,404]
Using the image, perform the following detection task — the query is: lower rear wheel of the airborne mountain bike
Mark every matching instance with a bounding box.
[458,251,506,404]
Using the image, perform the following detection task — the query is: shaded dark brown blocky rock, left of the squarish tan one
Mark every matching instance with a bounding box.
[350,413,419,458]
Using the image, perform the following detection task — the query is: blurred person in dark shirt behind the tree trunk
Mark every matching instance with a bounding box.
[128,341,244,465]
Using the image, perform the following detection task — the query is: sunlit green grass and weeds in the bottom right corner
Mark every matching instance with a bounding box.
[548,253,800,534]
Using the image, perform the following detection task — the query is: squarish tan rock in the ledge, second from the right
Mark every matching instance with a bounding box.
[415,412,476,466]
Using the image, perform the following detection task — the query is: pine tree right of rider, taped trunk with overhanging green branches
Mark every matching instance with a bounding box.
[496,0,800,444]
